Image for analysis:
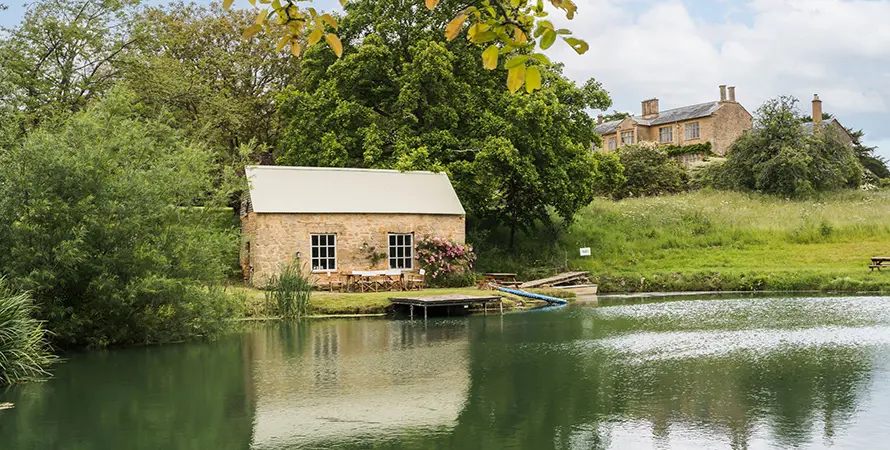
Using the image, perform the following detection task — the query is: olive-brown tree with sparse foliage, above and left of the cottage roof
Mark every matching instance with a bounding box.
[123,3,299,164]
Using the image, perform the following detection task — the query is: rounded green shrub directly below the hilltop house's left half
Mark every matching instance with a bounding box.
[617,142,689,198]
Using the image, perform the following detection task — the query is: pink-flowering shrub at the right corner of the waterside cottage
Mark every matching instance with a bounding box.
[414,236,476,284]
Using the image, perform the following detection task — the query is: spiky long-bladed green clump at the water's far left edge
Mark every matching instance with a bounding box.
[0,278,55,386]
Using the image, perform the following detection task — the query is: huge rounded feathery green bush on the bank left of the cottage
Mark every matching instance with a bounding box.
[0,89,238,347]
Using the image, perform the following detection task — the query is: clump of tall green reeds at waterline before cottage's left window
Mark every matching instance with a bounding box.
[265,262,313,319]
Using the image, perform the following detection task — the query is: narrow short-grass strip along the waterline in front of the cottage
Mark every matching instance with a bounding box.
[237,287,574,318]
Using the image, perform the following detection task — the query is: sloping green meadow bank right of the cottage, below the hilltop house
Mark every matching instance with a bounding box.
[551,191,890,292]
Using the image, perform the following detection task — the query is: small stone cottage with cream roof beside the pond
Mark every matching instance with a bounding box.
[241,166,466,286]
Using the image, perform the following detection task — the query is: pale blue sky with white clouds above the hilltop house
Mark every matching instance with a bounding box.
[0,0,890,158]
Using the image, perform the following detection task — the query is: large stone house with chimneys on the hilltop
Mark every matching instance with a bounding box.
[596,86,754,155]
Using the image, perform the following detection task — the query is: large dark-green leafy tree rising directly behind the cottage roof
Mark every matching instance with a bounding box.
[278,0,611,246]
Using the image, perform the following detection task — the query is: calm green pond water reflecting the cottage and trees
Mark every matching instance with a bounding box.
[0,297,890,450]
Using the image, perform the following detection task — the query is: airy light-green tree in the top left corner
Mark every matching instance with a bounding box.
[0,0,138,132]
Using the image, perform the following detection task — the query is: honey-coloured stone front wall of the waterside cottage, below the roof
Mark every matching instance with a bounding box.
[242,212,466,286]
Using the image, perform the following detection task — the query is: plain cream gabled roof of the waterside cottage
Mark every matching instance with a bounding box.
[246,166,466,215]
